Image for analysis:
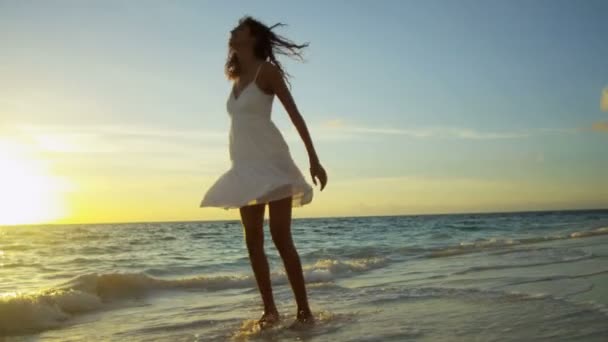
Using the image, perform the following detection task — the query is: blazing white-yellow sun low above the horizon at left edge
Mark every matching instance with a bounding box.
[0,142,66,225]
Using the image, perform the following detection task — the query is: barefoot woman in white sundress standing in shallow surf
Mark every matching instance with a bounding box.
[200,16,327,327]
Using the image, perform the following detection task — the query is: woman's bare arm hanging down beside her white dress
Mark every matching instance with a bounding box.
[264,62,327,190]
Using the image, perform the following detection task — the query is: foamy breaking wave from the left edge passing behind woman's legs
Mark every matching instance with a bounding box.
[0,258,386,335]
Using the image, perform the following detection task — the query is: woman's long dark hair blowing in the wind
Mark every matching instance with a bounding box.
[224,15,309,87]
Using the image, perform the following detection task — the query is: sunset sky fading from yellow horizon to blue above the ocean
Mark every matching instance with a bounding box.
[0,0,608,224]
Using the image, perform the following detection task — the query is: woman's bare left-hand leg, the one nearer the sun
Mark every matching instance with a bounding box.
[239,203,279,323]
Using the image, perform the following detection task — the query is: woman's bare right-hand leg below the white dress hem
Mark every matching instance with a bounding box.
[268,196,314,322]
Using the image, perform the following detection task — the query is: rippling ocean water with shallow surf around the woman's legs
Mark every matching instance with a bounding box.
[0,210,608,341]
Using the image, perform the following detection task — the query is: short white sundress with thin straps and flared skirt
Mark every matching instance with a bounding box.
[200,63,313,210]
